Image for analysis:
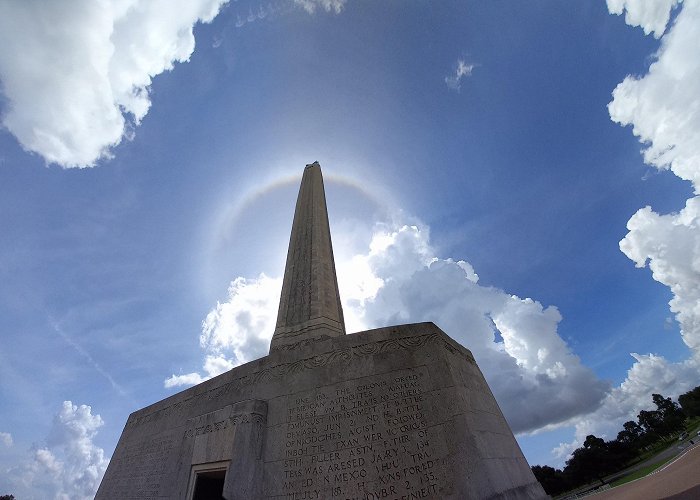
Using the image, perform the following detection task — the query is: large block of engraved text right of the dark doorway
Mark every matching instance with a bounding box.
[266,367,445,500]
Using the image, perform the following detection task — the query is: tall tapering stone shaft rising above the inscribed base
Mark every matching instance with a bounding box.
[270,162,345,350]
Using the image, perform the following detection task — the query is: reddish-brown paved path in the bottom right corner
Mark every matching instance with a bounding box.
[589,446,700,500]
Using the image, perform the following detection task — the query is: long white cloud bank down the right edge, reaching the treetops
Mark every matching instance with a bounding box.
[554,0,700,460]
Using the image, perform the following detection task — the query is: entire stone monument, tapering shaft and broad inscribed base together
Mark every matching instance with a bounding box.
[96,163,546,500]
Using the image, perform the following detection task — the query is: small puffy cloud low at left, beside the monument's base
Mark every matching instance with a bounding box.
[13,401,109,500]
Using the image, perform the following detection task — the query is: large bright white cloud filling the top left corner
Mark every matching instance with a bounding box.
[0,0,225,167]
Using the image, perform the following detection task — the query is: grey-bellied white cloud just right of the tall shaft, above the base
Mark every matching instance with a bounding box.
[352,226,608,432]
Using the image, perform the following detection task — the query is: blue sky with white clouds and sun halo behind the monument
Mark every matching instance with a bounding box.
[0,0,700,499]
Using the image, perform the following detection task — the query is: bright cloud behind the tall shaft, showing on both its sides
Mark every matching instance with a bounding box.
[165,221,609,432]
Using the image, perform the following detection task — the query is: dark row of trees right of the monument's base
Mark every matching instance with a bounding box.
[532,386,700,496]
